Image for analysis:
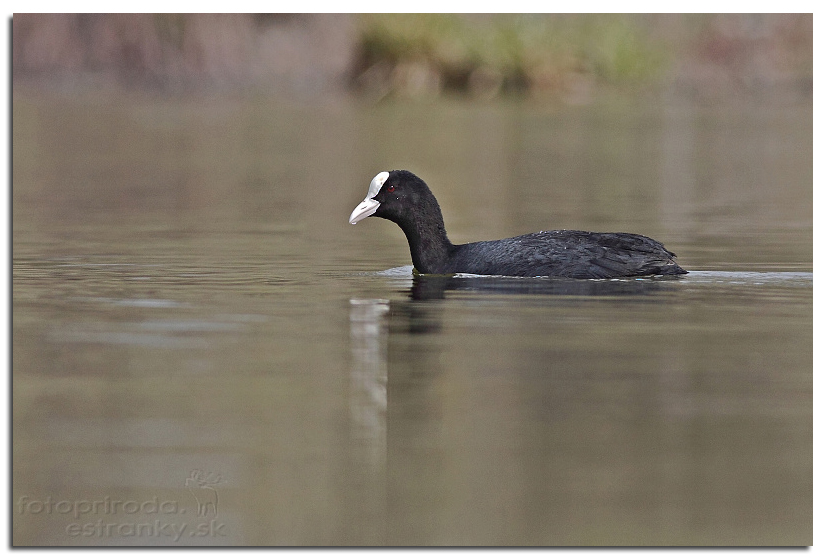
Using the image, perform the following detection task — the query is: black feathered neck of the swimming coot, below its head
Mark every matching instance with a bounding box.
[397,204,454,274]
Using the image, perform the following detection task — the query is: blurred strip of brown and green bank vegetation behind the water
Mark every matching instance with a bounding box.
[12,14,813,103]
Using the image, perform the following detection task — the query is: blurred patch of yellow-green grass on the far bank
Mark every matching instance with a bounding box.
[352,14,667,98]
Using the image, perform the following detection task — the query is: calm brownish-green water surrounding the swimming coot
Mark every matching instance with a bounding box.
[11,92,813,546]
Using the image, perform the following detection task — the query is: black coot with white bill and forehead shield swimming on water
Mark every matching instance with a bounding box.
[350,171,687,278]
